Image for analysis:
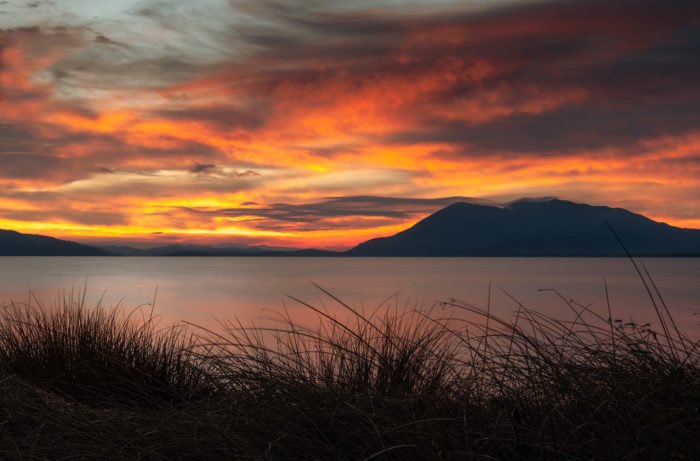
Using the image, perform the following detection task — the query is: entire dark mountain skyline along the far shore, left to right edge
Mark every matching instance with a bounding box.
[0,197,700,257]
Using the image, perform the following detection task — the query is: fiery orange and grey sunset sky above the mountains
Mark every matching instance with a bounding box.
[0,0,700,249]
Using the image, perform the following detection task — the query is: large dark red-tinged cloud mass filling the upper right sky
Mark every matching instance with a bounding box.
[216,0,700,155]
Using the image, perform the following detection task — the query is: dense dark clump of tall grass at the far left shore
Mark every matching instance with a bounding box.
[0,292,210,405]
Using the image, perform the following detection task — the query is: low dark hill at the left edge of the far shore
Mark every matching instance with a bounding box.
[0,229,110,256]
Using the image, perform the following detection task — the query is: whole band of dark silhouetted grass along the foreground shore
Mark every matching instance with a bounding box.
[0,274,700,460]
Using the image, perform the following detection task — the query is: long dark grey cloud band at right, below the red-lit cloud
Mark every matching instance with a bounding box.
[381,100,700,157]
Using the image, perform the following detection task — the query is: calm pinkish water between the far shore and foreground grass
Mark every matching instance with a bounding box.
[0,257,700,337]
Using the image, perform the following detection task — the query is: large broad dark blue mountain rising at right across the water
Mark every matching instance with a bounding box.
[346,198,700,256]
